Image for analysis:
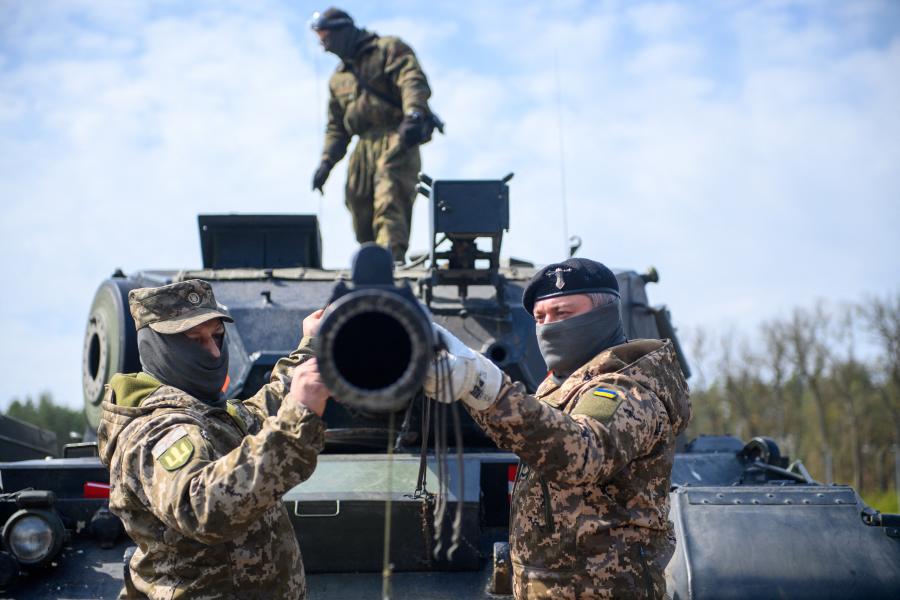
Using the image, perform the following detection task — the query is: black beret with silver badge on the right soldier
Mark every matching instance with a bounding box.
[522,258,619,314]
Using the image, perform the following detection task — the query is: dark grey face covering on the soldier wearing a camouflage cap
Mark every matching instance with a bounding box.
[138,327,228,403]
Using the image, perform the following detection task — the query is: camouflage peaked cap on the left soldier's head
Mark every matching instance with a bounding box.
[128,279,234,334]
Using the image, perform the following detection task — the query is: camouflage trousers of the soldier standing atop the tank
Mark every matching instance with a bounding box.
[345,129,422,260]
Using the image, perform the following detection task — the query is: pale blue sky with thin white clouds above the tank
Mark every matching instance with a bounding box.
[0,0,900,408]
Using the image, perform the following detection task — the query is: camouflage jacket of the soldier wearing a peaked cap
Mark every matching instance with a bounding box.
[97,336,325,599]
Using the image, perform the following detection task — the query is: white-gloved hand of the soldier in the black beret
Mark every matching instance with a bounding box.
[424,324,503,410]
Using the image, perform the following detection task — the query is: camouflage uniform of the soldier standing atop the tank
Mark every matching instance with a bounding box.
[322,34,431,260]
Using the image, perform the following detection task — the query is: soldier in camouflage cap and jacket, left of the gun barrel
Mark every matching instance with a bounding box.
[97,280,328,599]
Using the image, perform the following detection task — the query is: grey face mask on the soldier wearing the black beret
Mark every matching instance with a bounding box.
[536,300,625,378]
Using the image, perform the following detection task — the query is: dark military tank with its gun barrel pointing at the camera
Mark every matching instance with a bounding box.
[0,175,900,600]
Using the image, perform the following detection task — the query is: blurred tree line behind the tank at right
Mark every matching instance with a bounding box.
[686,294,900,512]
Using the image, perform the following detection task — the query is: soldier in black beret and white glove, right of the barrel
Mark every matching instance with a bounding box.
[425,258,691,599]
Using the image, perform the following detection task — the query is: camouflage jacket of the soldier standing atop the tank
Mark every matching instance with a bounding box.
[322,34,431,164]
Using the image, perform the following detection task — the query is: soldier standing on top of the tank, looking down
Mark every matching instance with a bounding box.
[311,8,440,262]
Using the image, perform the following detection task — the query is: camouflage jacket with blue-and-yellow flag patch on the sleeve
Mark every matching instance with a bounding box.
[472,340,691,600]
